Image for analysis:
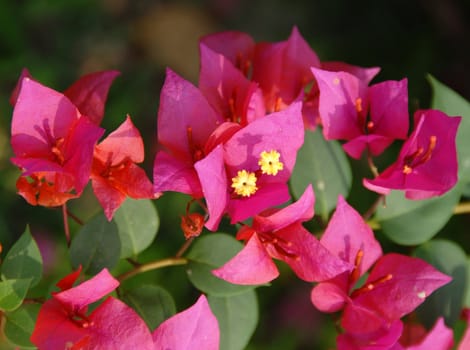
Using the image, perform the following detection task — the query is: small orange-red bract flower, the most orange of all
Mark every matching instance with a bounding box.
[91,116,158,220]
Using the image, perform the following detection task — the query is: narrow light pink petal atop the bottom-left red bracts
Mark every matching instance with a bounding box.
[53,269,119,312]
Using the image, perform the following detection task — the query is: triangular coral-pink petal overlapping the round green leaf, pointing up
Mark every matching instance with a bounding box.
[212,234,279,285]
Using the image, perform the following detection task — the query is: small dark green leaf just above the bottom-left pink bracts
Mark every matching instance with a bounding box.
[122,285,176,331]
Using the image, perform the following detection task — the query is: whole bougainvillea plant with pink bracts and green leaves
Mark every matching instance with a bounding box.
[0,28,470,350]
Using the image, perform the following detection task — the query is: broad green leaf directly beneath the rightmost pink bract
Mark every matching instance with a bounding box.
[375,186,461,245]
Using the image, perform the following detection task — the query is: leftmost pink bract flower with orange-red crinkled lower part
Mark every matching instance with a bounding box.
[11,78,104,206]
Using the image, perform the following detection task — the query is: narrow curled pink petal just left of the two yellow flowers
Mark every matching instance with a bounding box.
[194,146,228,231]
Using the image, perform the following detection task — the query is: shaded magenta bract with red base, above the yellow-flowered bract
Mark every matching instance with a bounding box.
[199,44,266,126]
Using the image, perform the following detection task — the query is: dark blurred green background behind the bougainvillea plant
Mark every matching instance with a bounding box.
[0,0,470,349]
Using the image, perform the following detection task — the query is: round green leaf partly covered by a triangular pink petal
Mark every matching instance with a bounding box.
[186,233,254,296]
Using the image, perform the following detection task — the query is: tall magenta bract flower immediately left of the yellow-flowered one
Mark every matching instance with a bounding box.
[153,69,223,198]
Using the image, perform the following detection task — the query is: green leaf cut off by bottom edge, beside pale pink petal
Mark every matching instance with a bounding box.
[208,290,258,350]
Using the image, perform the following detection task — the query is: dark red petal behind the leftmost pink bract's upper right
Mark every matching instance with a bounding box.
[64,71,120,125]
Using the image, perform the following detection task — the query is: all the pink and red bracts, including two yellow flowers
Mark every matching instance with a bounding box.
[11,28,464,349]
